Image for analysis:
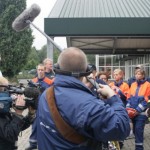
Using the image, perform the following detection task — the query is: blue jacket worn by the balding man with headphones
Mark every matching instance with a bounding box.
[37,75,130,150]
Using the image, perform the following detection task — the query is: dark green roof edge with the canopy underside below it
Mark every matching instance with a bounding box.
[44,17,150,54]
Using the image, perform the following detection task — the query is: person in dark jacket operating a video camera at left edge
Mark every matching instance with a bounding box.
[0,77,35,150]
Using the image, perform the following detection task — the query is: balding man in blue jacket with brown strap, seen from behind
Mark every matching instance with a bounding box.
[37,47,130,150]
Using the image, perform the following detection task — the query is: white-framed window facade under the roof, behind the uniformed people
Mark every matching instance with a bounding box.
[96,54,150,80]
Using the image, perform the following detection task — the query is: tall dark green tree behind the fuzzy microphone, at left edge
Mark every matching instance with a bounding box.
[0,0,33,77]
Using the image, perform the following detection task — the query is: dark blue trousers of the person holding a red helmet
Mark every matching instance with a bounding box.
[132,115,147,150]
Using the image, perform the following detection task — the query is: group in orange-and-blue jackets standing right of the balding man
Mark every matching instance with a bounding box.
[97,65,150,150]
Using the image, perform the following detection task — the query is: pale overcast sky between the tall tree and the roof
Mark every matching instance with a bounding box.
[27,0,66,49]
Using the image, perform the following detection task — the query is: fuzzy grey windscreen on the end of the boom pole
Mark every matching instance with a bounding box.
[12,4,41,32]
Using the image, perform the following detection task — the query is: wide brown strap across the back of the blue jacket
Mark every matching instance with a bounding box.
[46,86,88,144]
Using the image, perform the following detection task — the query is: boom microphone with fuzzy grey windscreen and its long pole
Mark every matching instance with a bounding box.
[12,4,62,51]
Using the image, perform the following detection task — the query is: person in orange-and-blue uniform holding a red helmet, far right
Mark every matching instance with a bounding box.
[126,69,150,150]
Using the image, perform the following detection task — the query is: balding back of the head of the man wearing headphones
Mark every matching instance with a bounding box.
[57,47,87,73]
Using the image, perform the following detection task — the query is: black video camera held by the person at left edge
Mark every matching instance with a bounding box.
[0,81,40,112]
